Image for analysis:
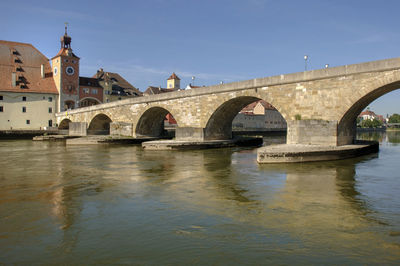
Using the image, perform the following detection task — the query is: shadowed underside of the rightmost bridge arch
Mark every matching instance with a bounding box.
[337,81,400,146]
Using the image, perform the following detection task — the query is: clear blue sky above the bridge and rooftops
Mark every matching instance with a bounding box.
[0,0,400,115]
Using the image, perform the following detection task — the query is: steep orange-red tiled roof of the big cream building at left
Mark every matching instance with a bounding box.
[0,40,58,94]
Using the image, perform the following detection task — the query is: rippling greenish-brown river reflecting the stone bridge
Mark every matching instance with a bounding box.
[0,132,400,265]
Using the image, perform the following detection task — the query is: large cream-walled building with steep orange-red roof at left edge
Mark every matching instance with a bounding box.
[0,41,59,130]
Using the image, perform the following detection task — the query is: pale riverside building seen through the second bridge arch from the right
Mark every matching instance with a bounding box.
[232,100,287,130]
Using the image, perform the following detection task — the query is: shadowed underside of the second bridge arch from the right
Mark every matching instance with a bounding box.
[204,96,286,140]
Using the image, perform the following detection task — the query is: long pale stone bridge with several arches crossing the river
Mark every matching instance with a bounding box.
[56,58,400,146]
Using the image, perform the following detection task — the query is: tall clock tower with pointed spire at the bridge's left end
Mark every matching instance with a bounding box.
[51,23,79,112]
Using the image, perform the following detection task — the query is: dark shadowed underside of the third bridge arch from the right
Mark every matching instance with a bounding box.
[135,107,177,137]
